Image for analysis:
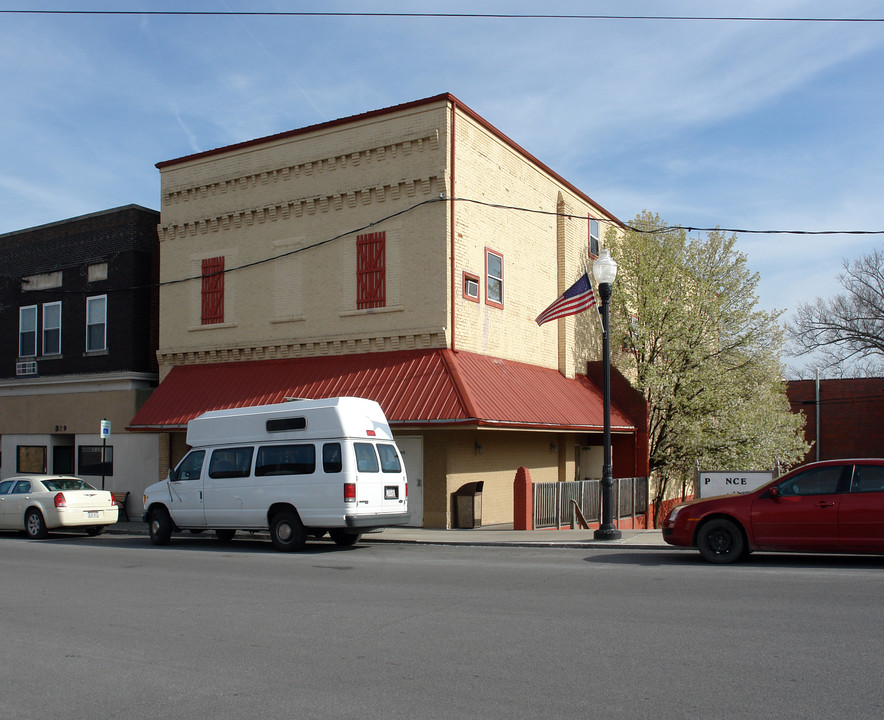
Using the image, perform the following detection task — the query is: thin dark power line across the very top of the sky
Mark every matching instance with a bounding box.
[0,10,884,23]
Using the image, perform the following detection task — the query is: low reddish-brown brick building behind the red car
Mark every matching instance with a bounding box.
[787,377,884,462]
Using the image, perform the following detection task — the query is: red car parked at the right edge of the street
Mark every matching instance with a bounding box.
[663,458,884,563]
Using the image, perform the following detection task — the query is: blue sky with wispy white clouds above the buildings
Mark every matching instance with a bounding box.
[0,0,884,372]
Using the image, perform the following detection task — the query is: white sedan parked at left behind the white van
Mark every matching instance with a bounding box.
[0,475,120,540]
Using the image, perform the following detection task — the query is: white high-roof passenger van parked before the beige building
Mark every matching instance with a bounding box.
[142,397,408,550]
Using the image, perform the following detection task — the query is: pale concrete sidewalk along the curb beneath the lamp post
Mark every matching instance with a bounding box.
[105,521,675,550]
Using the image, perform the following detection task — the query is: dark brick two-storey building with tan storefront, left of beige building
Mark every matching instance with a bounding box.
[0,205,160,512]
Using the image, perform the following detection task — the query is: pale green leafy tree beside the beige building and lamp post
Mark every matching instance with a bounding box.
[607,212,807,522]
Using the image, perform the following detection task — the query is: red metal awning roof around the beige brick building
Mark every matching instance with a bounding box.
[127,349,635,431]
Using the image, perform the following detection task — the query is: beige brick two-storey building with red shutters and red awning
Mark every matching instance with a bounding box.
[131,94,647,527]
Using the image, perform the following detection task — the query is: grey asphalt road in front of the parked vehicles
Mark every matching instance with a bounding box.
[0,534,884,720]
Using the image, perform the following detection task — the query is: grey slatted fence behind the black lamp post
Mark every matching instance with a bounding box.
[534,477,649,528]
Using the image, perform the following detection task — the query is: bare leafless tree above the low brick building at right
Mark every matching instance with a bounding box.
[788,250,884,372]
